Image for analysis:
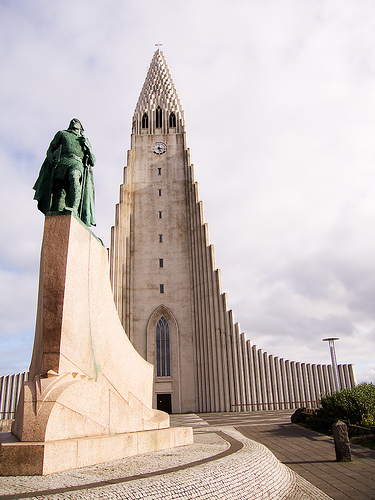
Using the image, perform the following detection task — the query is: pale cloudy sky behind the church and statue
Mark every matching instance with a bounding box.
[0,0,375,382]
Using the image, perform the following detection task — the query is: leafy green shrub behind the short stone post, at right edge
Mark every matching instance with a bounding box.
[318,383,375,427]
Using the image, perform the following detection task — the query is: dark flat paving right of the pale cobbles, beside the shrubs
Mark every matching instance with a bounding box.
[198,410,375,500]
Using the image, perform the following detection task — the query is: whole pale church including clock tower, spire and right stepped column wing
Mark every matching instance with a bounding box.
[110,49,355,413]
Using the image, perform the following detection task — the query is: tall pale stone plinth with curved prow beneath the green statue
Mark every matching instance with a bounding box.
[0,215,192,475]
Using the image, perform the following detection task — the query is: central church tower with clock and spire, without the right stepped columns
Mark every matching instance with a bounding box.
[112,50,196,413]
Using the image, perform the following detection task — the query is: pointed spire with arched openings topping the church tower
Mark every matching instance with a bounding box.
[133,48,184,134]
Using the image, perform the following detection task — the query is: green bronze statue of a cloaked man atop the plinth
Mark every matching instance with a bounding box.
[33,118,95,226]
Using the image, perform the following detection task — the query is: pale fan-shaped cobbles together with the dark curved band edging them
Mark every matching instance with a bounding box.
[0,427,330,500]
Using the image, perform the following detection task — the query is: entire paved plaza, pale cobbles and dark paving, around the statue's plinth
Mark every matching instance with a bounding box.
[0,410,375,500]
